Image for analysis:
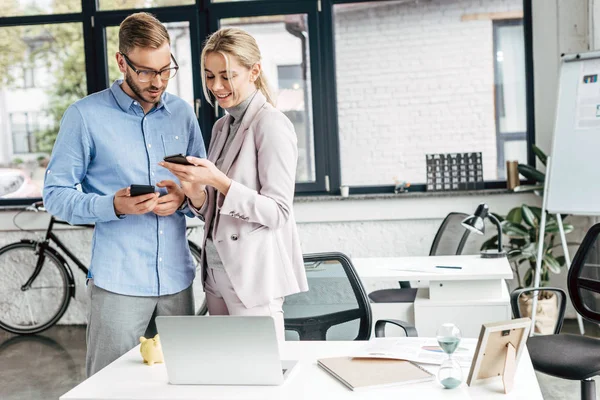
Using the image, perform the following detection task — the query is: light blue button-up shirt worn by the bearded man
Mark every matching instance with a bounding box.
[43,80,206,296]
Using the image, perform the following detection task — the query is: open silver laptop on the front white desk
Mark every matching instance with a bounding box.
[156,315,298,385]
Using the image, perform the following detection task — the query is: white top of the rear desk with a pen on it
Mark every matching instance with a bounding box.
[352,255,513,281]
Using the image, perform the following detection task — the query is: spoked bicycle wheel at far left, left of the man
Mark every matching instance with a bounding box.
[0,242,71,334]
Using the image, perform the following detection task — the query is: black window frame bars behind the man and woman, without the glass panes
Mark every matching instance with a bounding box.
[0,0,535,207]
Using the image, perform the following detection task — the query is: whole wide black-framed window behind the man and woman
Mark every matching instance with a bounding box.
[0,0,533,204]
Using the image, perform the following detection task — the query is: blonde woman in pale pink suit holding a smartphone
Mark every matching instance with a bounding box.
[160,28,308,340]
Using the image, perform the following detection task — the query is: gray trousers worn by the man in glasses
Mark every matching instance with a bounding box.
[85,279,194,378]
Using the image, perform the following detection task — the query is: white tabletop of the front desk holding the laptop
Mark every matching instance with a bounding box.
[60,339,542,400]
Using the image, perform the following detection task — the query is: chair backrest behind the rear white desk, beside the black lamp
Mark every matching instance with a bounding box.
[429,212,469,256]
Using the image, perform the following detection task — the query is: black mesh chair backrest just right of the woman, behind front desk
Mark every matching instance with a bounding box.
[283,253,372,340]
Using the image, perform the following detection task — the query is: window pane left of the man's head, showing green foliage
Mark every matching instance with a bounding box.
[0,23,87,203]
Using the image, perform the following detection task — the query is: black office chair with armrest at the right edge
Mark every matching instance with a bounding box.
[511,224,600,400]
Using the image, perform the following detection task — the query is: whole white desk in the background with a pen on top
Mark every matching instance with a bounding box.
[352,256,513,338]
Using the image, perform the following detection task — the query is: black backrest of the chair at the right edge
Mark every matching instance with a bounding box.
[567,224,600,323]
